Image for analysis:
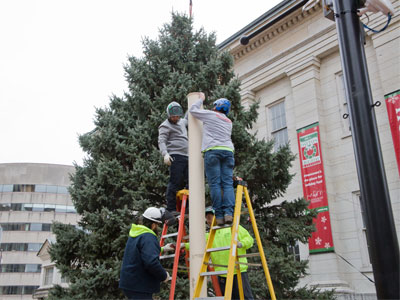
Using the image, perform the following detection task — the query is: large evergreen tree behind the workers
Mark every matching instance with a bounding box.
[50,13,332,299]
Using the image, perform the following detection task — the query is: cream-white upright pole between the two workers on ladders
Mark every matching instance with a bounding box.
[187,93,207,299]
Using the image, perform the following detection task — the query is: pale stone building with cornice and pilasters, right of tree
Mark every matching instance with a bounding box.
[219,0,400,299]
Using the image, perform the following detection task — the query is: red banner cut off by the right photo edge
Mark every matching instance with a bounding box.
[385,90,400,176]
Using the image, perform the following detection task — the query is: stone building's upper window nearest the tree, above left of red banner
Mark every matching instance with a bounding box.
[268,101,289,151]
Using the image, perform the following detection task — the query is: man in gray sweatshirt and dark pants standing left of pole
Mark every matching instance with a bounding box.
[158,102,188,218]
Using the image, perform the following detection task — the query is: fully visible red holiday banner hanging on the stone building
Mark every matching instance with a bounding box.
[297,123,334,253]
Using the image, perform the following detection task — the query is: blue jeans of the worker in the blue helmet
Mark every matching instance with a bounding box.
[204,150,235,219]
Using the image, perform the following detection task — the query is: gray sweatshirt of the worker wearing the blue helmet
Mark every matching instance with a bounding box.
[189,99,235,151]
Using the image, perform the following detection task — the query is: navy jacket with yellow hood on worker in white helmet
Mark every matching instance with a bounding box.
[119,224,167,293]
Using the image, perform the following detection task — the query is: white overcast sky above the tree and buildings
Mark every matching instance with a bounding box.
[0,0,280,165]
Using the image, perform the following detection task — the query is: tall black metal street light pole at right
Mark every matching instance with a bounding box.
[333,0,400,299]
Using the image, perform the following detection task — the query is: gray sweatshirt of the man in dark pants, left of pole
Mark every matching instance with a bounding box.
[158,118,188,156]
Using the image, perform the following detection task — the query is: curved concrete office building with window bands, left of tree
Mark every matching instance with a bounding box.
[0,163,79,299]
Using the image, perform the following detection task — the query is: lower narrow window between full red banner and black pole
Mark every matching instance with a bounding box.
[353,192,371,267]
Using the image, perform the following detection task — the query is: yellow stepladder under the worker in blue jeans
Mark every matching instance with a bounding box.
[193,180,276,300]
